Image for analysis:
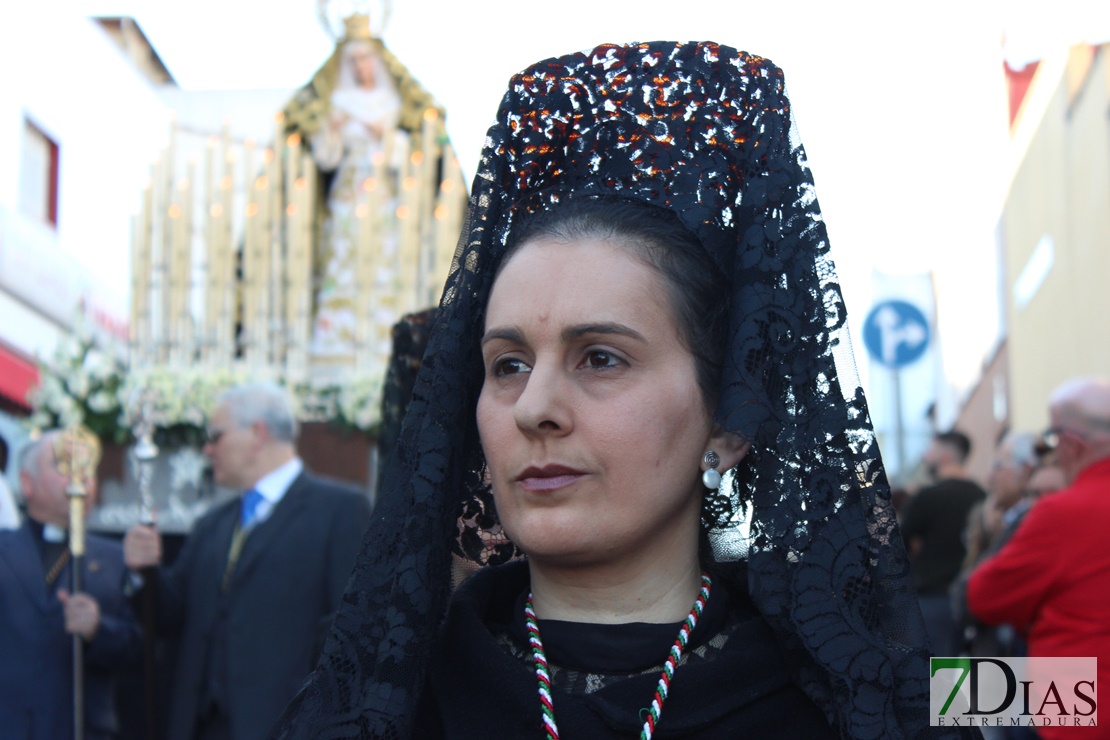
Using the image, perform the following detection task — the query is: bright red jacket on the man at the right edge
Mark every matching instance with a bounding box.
[968,459,1110,740]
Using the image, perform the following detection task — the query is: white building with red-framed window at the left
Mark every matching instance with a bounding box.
[0,11,171,483]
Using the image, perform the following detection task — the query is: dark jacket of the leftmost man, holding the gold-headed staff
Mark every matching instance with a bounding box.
[0,524,142,740]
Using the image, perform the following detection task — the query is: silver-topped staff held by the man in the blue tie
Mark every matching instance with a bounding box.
[131,399,159,740]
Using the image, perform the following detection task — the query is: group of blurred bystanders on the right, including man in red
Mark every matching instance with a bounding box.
[901,377,1110,739]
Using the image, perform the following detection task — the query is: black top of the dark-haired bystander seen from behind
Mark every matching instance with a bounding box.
[901,478,987,596]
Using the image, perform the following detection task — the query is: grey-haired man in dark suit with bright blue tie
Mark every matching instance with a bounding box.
[124,384,370,740]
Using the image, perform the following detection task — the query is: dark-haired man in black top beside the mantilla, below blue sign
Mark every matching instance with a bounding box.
[901,430,987,656]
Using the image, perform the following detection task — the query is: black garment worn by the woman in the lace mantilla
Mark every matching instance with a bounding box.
[414,561,836,740]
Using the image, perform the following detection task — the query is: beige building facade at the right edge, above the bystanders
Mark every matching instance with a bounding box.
[1001,44,1110,430]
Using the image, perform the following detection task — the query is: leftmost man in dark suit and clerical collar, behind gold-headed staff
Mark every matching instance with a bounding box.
[0,432,141,740]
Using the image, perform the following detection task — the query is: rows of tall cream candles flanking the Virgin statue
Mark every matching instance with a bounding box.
[131,109,466,383]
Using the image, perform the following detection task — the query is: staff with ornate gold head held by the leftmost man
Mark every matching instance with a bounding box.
[54,426,100,740]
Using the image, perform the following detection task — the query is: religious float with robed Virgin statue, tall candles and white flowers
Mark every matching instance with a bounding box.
[32,0,466,534]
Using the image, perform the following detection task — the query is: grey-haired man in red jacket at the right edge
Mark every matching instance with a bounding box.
[968,378,1110,738]
